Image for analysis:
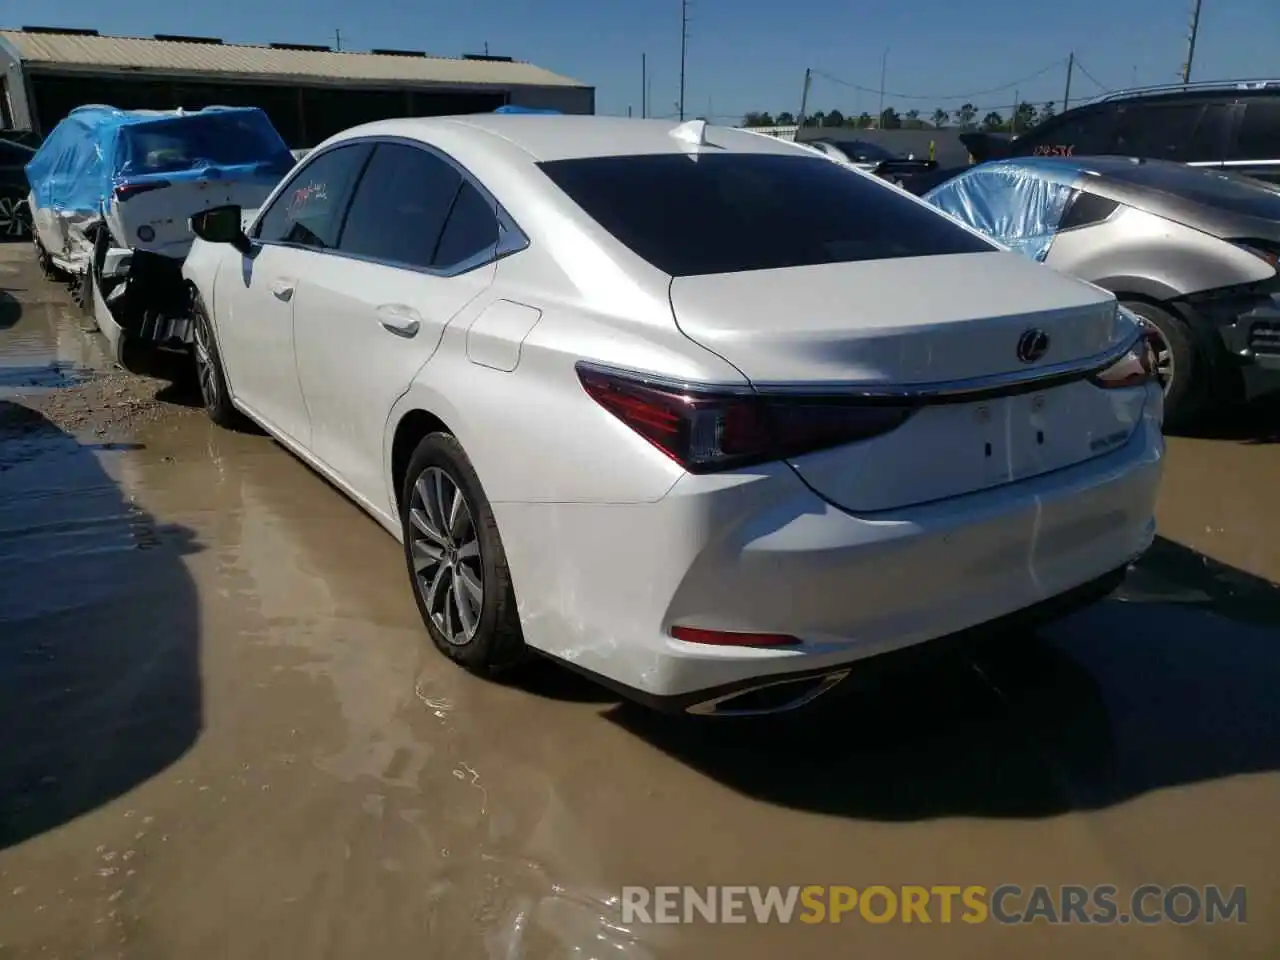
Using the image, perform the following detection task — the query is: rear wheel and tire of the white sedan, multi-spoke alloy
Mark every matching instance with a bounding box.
[401,433,527,676]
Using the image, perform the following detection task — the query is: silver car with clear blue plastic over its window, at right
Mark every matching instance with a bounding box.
[924,156,1280,428]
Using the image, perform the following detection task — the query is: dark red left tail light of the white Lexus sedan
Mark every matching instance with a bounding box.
[577,362,916,474]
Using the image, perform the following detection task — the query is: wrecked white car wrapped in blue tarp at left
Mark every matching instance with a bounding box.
[27,105,294,365]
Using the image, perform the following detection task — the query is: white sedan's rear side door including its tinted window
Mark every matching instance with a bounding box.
[294,142,498,511]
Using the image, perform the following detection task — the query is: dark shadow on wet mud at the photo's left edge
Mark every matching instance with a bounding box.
[0,401,202,850]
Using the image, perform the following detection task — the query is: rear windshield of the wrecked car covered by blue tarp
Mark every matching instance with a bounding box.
[119,111,293,175]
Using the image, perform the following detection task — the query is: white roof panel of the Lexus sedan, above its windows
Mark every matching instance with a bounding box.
[378,114,810,163]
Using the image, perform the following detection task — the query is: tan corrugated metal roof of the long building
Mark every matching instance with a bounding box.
[0,29,586,87]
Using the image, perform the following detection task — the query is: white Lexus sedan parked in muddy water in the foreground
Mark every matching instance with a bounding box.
[184,115,1164,714]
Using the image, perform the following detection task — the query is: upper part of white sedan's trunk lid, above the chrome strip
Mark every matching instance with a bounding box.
[671,252,1123,385]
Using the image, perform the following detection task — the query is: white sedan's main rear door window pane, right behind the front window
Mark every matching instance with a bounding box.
[339,143,462,266]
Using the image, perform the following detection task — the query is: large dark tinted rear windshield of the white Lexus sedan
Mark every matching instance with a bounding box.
[540,154,997,276]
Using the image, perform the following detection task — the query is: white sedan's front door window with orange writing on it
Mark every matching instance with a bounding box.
[253,143,371,250]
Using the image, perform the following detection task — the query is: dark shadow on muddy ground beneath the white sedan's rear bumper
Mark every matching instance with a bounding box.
[605,539,1280,820]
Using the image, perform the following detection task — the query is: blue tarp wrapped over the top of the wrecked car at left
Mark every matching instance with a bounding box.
[27,106,293,216]
